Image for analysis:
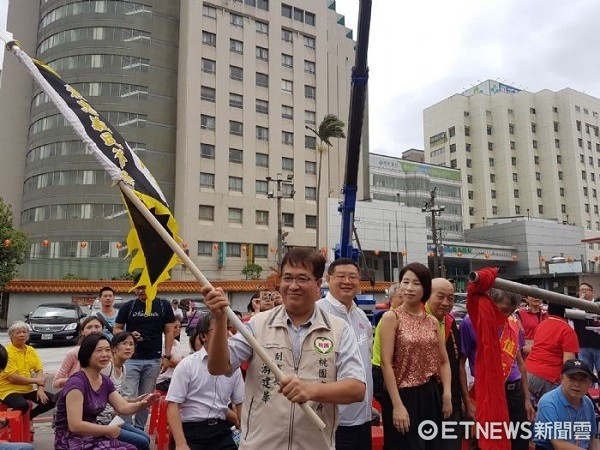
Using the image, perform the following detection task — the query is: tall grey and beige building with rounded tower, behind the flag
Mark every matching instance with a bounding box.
[0,0,368,280]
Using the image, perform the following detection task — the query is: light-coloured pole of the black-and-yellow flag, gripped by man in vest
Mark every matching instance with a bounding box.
[118,181,325,431]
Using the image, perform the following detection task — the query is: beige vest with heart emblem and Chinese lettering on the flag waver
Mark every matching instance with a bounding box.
[240,306,345,450]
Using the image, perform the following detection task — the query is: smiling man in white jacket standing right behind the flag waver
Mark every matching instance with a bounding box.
[317,258,373,450]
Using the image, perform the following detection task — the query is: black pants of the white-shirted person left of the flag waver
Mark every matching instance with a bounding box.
[171,419,237,450]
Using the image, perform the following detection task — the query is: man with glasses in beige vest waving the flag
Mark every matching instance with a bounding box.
[202,248,365,450]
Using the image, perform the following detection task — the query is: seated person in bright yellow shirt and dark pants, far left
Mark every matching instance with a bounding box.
[0,321,56,419]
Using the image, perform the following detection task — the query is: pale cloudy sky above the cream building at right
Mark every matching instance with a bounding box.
[336,0,600,156]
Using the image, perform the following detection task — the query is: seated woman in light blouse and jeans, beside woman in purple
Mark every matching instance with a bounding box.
[97,331,150,450]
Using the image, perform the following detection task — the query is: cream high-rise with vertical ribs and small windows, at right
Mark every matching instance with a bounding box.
[424,80,600,262]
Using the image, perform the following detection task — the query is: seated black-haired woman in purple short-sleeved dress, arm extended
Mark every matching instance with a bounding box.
[54,333,158,450]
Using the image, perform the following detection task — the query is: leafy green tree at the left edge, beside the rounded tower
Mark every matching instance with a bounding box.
[0,198,27,290]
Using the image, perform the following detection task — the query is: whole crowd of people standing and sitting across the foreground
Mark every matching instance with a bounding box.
[0,248,600,450]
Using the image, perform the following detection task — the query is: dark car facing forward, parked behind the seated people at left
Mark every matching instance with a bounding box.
[25,303,86,344]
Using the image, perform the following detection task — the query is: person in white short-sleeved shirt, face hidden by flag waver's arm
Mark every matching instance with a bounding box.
[166,314,244,450]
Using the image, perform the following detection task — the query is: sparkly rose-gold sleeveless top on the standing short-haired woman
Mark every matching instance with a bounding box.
[392,308,442,388]
